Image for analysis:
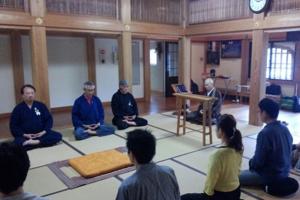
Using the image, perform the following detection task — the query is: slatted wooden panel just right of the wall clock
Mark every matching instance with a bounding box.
[270,0,300,15]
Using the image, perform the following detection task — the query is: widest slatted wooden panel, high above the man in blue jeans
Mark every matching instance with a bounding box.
[46,0,120,19]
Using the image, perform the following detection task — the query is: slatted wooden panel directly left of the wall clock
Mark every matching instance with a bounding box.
[188,0,253,24]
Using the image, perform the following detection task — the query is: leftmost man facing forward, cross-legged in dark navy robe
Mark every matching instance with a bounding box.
[9,85,62,150]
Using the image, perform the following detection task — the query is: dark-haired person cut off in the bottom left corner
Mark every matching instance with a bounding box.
[0,142,46,200]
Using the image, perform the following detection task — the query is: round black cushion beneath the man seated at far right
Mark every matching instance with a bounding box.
[266,177,299,197]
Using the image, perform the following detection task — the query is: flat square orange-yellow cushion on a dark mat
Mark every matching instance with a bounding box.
[68,149,132,178]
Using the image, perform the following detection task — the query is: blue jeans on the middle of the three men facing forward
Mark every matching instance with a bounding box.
[74,124,115,140]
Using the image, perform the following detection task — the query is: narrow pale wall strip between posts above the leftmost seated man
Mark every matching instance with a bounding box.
[21,35,32,84]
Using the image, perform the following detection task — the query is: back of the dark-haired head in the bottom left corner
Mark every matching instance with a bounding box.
[0,142,30,194]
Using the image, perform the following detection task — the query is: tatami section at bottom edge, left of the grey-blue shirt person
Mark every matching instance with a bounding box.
[48,178,121,200]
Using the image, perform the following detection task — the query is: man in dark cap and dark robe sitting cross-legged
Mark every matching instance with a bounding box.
[111,80,148,130]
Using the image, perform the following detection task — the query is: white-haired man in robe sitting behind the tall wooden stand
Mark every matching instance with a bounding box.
[186,78,222,124]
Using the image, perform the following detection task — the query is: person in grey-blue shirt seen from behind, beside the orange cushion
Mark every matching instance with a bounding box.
[116,129,180,200]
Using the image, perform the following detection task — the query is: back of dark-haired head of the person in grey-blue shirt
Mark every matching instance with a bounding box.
[126,129,156,164]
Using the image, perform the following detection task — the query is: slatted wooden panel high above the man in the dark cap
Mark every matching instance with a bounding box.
[131,0,182,25]
